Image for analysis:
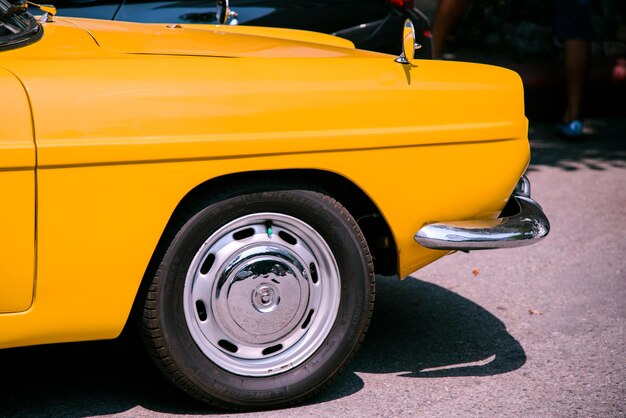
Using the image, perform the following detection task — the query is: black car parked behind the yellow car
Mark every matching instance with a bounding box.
[35,0,432,58]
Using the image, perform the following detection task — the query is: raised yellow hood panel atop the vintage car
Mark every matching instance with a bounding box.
[59,18,379,58]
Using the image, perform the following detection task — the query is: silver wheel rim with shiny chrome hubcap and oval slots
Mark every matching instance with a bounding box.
[184,213,341,376]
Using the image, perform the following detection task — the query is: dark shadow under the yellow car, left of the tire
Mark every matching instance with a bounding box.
[0,332,222,418]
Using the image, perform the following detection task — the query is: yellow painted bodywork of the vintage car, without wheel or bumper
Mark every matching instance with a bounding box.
[0,7,544,408]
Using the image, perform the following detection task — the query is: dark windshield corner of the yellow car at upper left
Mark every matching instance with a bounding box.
[0,0,43,51]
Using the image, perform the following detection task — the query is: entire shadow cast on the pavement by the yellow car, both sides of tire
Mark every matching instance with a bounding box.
[0,276,526,417]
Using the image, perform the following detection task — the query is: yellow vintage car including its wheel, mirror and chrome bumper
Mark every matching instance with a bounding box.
[0,0,549,409]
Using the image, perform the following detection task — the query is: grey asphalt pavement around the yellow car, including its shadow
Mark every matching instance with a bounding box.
[0,118,626,417]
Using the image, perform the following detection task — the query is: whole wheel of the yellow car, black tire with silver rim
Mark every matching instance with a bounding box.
[142,190,374,409]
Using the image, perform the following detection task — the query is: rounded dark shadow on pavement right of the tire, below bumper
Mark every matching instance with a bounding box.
[353,277,526,377]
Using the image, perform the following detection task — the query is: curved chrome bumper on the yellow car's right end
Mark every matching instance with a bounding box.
[414,177,550,251]
